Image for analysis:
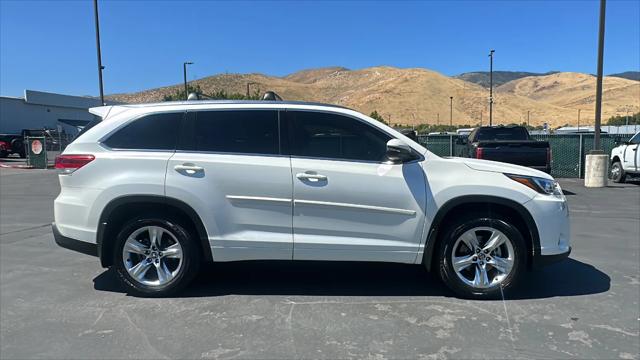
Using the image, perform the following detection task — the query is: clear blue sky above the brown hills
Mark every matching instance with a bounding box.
[0,0,640,96]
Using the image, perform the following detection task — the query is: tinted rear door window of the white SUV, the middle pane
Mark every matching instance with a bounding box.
[178,110,280,155]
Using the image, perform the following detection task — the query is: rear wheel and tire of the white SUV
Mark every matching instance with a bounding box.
[113,216,201,297]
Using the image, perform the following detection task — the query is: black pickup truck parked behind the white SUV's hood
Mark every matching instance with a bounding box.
[458,126,551,174]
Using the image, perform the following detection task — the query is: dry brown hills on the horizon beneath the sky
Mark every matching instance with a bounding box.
[109,66,640,126]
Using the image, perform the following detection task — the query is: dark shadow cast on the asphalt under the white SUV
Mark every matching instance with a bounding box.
[93,259,611,300]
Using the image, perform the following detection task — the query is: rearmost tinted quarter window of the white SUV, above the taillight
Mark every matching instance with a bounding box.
[104,112,184,150]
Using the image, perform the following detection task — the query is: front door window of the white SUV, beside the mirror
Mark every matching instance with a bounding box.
[287,111,391,161]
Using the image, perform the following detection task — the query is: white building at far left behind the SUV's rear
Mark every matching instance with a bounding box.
[0,90,119,134]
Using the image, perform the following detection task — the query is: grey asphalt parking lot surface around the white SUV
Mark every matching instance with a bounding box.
[0,169,640,359]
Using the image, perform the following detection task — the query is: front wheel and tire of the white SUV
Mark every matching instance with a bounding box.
[438,214,526,299]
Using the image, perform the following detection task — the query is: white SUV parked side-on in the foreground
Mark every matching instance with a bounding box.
[53,101,571,298]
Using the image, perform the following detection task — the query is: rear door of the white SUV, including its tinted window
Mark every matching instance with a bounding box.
[166,110,293,261]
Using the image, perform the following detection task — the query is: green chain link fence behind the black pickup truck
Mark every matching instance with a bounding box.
[418,134,631,178]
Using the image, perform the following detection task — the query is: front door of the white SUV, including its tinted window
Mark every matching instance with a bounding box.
[286,111,426,263]
